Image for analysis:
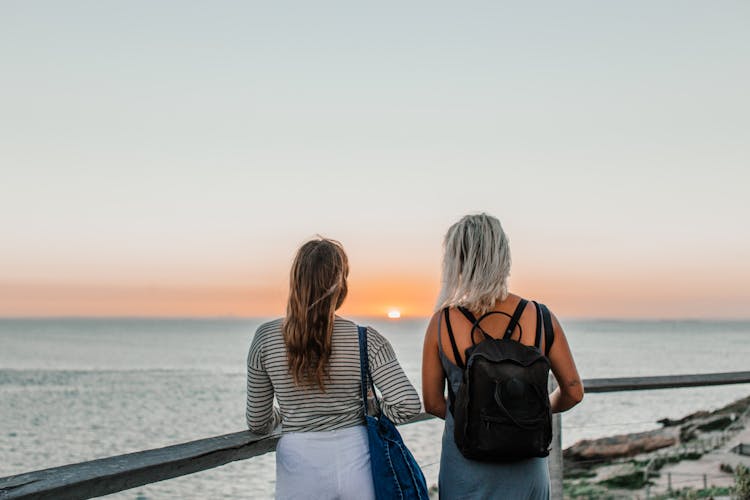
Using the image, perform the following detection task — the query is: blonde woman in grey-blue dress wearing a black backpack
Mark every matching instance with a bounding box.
[422,214,583,500]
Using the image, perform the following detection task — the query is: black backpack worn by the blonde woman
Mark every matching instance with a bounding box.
[443,299,554,462]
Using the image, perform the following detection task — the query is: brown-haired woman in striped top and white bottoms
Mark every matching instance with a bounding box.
[246,238,421,499]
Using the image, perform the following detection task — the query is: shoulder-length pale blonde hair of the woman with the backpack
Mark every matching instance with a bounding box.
[437,213,510,314]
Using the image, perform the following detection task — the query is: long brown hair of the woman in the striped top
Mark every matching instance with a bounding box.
[283,238,349,391]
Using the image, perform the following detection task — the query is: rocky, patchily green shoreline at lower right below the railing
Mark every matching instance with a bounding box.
[563,396,750,498]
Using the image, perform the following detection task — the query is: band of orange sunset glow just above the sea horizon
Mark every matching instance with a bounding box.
[0,273,750,319]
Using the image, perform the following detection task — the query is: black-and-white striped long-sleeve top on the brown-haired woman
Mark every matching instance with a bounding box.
[246,317,421,434]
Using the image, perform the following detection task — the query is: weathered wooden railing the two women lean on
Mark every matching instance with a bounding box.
[0,371,750,500]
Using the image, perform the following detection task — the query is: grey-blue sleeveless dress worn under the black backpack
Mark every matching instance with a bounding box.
[438,322,549,500]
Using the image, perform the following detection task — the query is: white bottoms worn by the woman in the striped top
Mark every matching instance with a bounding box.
[276,425,375,500]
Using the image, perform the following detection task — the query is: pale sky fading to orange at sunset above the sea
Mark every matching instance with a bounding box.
[0,0,750,318]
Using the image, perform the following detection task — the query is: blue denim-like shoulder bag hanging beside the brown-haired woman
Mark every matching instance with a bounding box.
[357,326,429,500]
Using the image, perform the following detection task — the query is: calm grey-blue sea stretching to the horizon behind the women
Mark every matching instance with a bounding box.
[0,319,750,499]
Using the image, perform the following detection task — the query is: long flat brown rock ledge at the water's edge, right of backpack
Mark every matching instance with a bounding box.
[563,428,680,462]
